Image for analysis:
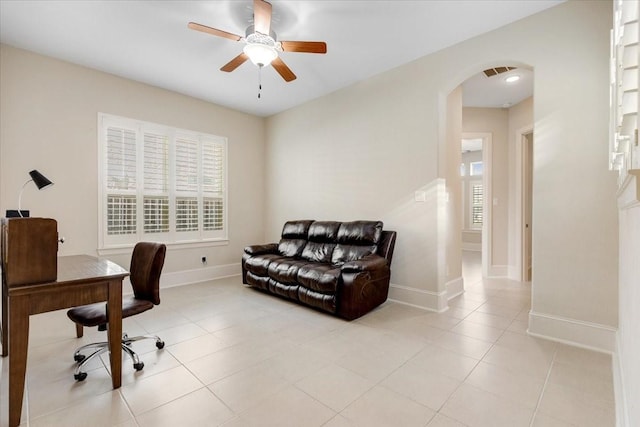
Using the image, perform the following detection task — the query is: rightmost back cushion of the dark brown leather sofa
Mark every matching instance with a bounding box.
[331,221,383,265]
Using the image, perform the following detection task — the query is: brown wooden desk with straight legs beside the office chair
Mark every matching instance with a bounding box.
[2,255,129,427]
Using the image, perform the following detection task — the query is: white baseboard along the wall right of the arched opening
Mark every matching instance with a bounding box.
[527,311,617,354]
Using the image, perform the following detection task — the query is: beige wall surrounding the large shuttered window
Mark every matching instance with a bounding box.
[0,45,264,273]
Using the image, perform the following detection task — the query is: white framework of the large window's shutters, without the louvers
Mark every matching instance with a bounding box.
[97,113,229,254]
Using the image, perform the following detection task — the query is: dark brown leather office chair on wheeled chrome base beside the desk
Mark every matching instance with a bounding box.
[67,242,167,381]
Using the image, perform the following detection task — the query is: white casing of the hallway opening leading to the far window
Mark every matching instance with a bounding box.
[460,132,493,277]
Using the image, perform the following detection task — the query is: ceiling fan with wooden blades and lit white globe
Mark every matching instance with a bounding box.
[189,0,327,82]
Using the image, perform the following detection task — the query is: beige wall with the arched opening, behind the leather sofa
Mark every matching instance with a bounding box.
[266,1,617,344]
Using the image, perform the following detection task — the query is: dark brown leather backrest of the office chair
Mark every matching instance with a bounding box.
[129,242,167,305]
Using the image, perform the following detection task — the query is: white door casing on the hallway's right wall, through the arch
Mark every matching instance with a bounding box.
[511,125,533,281]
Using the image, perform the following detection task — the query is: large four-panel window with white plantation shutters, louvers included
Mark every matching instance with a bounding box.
[98,114,227,248]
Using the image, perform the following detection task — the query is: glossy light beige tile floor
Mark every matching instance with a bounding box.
[0,253,615,427]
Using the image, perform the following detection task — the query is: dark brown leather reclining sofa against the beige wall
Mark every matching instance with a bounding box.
[242,220,396,320]
